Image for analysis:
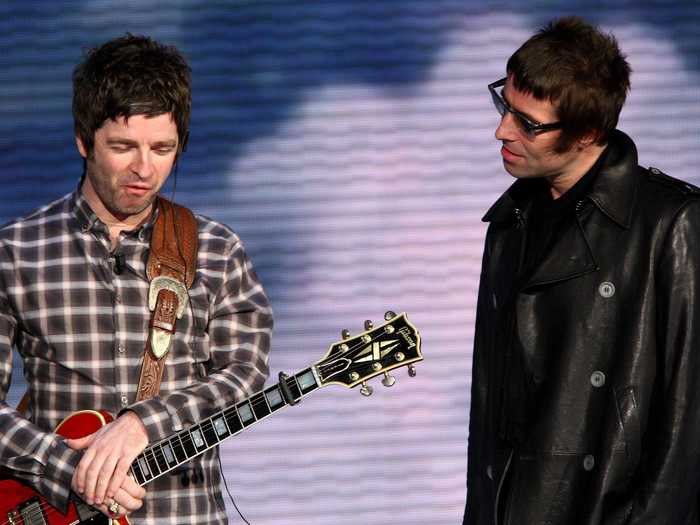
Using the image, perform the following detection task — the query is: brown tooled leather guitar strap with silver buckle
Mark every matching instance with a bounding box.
[136,197,197,401]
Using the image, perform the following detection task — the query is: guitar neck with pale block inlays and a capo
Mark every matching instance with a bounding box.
[131,367,319,486]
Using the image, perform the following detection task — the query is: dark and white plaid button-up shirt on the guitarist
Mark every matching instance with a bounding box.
[0,187,272,524]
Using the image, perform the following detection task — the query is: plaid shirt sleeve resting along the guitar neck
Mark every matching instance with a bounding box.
[126,234,272,442]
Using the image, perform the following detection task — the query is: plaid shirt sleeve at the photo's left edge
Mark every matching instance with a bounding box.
[0,258,81,513]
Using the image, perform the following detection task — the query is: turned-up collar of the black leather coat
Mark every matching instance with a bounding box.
[482,130,638,228]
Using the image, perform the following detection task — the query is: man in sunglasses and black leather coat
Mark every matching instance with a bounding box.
[464,18,700,525]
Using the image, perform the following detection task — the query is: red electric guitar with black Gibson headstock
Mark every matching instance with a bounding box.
[0,312,423,525]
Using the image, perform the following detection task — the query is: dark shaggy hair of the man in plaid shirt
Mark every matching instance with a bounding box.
[73,33,192,154]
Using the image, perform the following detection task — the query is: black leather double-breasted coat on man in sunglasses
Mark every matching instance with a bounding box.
[464,132,700,525]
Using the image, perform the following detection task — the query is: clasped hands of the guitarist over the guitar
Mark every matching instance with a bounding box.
[66,412,148,509]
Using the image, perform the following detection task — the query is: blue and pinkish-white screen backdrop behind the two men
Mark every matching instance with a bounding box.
[0,0,700,525]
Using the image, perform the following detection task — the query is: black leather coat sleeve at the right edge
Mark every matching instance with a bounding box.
[616,199,700,525]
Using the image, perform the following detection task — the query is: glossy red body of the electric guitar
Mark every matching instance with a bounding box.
[0,410,129,525]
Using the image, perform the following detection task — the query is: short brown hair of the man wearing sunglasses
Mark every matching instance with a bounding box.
[507,17,631,153]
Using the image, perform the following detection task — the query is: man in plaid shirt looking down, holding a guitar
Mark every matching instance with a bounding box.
[0,35,272,524]
